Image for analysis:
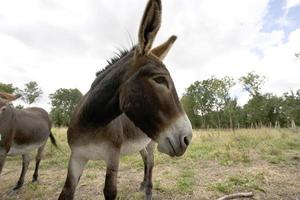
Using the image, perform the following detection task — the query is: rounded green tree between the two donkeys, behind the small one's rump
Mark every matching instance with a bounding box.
[49,88,82,126]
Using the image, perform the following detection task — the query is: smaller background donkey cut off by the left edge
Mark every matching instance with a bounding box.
[0,92,57,190]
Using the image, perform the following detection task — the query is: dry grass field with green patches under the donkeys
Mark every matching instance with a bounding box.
[0,129,300,200]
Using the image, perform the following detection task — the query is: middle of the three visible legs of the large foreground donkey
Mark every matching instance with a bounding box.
[103,149,120,200]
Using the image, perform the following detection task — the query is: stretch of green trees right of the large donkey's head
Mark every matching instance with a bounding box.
[181,72,300,129]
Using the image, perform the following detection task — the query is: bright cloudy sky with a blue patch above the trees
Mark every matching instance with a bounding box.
[0,0,300,109]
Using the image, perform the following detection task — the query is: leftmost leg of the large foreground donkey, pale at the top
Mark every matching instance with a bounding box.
[58,153,88,200]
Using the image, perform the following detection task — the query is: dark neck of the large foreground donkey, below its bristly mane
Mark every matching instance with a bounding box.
[75,53,132,129]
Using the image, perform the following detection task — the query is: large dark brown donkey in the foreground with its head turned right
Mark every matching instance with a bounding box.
[59,0,192,200]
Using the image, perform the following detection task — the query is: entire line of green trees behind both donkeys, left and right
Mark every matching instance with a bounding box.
[0,72,300,129]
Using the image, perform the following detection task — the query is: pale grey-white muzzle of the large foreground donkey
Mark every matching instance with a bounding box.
[157,115,192,157]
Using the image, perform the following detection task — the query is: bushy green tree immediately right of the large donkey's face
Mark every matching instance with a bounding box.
[182,77,234,128]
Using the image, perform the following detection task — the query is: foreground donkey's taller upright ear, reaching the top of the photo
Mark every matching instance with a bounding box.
[138,0,161,55]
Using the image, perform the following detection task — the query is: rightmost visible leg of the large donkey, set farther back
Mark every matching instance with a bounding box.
[140,141,155,200]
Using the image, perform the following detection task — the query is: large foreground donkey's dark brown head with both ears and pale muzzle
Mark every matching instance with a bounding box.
[119,0,192,156]
